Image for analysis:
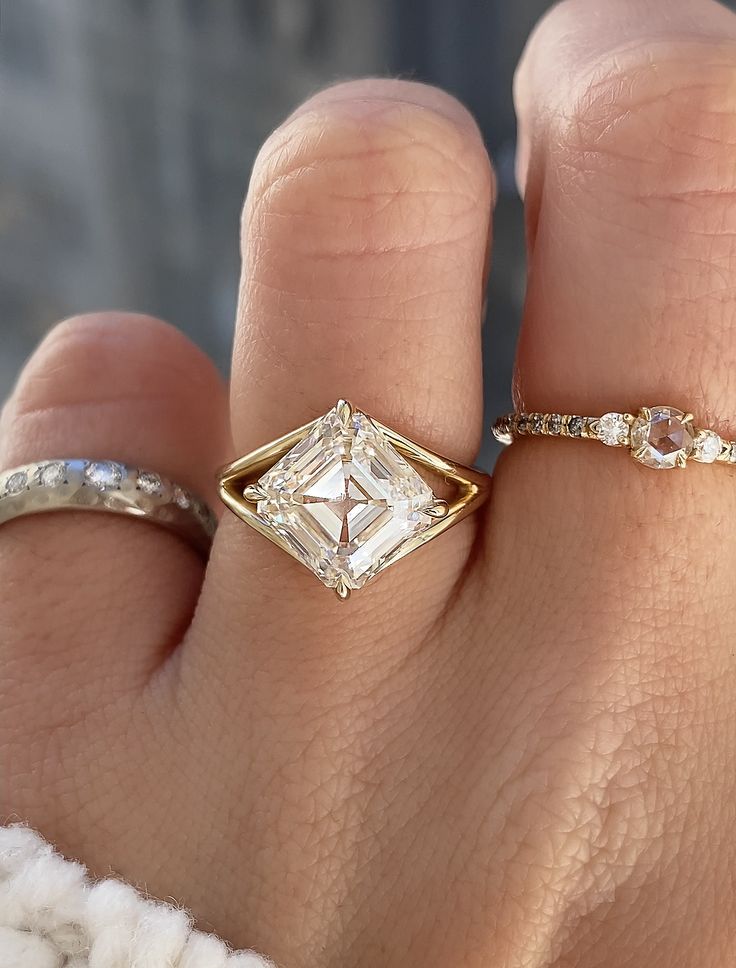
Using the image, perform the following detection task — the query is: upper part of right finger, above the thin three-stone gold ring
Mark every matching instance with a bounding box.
[516,0,736,414]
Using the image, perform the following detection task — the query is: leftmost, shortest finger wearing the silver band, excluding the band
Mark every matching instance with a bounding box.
[0,313,227,700]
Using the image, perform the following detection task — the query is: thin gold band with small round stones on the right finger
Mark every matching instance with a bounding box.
[493,406,736,470]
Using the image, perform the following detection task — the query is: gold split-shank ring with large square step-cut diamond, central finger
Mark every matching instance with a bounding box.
[219,400,490,600]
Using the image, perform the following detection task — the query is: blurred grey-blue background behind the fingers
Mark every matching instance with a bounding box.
[0,0,549,464]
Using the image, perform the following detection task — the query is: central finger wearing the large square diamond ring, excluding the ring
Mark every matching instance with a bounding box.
[196,80,491,648]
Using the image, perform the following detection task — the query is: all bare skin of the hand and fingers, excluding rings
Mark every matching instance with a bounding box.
[0,0,736,968]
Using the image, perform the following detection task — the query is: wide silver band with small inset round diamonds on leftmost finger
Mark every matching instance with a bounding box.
[0,457,217,556]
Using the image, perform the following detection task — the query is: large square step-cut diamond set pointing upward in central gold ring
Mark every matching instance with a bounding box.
[257,408,435,588]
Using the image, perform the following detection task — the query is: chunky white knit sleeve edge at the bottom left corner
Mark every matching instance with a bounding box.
[0,826,273,968]
